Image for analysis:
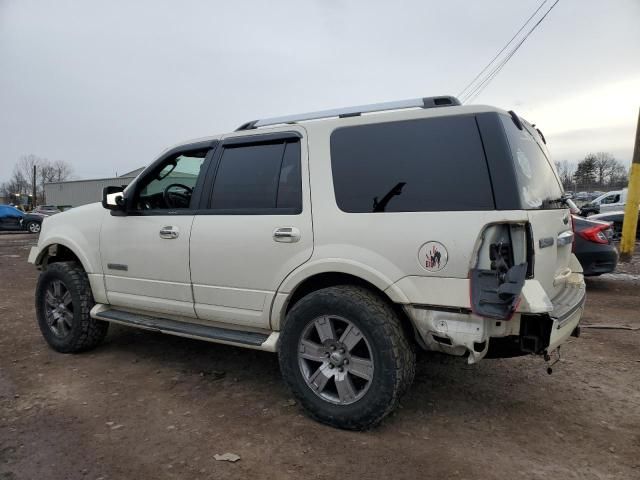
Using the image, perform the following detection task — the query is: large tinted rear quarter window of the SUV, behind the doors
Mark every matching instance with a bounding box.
[331,116,494,213]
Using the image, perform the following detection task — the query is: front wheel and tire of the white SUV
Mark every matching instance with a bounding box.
[36,262,109,353]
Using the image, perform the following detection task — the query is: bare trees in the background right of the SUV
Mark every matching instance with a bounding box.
[555,152,629,191]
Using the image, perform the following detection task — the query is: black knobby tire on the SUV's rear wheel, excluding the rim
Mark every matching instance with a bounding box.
[279,285,416,430]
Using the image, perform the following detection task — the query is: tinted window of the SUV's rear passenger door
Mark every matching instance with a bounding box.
[211,141,302,213]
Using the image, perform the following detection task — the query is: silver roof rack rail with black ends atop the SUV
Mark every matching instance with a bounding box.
[236,95,461,131]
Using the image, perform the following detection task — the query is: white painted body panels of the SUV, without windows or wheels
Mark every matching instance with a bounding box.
[29,106,584,362]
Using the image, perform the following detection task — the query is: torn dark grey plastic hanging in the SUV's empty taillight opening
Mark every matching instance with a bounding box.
[471,262,527,320]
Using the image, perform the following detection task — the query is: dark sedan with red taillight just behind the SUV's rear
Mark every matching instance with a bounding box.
[572,215,618,276]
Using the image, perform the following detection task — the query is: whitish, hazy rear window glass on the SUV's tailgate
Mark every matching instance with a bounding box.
[500,115,564,210]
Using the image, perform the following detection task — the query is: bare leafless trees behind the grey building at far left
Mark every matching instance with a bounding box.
[0,154,73,205]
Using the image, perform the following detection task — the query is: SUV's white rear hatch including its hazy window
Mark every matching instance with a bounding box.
[500,115,573,299]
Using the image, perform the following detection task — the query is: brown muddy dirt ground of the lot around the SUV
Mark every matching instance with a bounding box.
[0,235,640,480]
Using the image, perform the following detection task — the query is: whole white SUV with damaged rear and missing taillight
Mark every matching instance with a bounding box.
[29,97,585,429]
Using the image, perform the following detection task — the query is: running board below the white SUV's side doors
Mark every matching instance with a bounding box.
[91,305,278,352]
